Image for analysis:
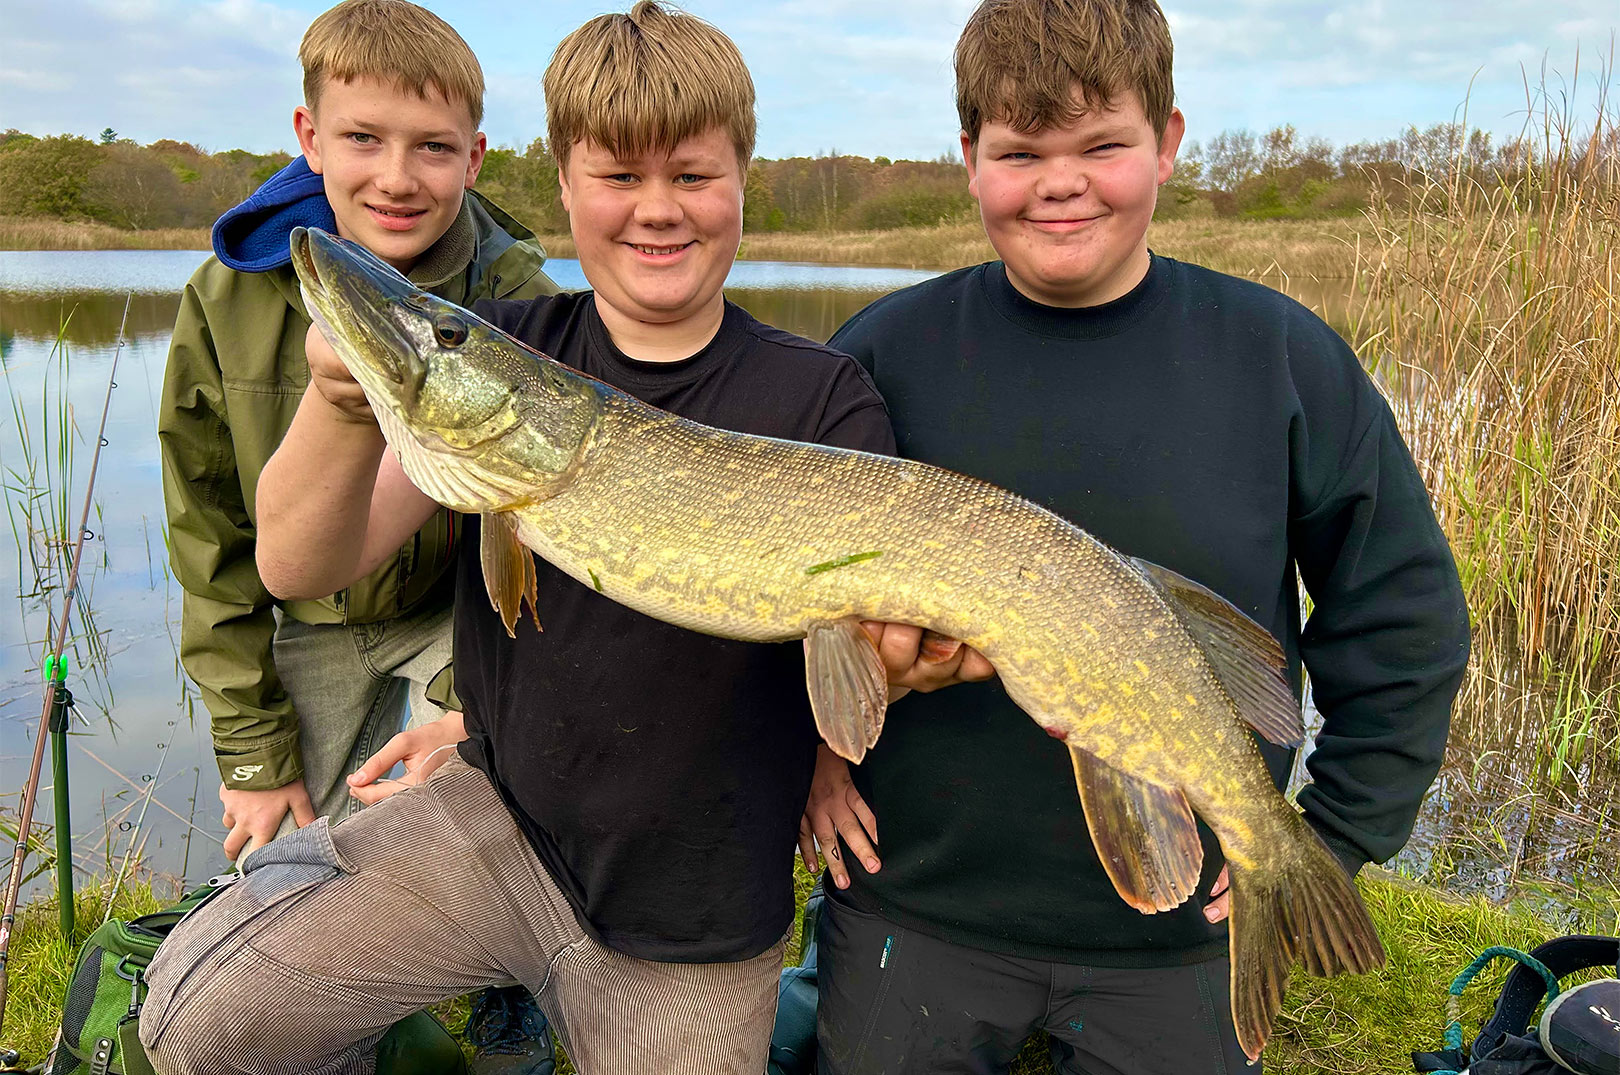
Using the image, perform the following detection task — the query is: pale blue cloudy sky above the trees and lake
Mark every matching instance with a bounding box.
[0,0,1620,159]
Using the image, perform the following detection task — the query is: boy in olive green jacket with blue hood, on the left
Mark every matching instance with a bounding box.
[159,0,556,858]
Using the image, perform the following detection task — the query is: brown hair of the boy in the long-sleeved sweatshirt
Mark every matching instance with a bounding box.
[956,0,1176,144]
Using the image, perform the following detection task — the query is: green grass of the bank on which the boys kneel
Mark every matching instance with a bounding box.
[5,869,1581,1075]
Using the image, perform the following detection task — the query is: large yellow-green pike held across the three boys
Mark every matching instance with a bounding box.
[292,230,1383,1057]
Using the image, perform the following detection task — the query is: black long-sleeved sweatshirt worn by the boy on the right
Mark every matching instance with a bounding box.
[833,257,1468,967]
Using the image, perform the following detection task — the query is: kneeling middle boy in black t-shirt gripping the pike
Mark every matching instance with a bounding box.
[141,2,893,1075]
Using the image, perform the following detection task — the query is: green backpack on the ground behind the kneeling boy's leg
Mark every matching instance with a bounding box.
[45,874,467,1075]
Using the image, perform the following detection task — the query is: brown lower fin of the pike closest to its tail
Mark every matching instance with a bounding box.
[1069,746,1204,915]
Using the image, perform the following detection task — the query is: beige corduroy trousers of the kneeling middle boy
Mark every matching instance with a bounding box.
[141,758,782,1075]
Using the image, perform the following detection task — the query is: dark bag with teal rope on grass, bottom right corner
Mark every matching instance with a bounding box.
[1413,936,1620,1075]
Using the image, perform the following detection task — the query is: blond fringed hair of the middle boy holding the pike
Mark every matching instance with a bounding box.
[544,0,755,170]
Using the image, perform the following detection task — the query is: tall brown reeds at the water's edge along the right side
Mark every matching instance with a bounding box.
[1351,90,1620,841]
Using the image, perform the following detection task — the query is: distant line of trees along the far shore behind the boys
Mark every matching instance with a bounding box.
[0,123,1568,233]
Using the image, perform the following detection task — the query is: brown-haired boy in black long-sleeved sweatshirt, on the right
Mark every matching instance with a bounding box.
[805,0,1468,1075]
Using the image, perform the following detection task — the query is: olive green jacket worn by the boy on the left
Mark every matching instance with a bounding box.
[157,191,557,790]
